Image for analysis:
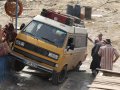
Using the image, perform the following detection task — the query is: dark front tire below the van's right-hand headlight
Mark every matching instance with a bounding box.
[52,66,67,85]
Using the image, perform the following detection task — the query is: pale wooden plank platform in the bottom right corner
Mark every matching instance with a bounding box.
[88,69,120,90]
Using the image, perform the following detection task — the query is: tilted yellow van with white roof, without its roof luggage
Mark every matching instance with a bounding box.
[11,9,87,84]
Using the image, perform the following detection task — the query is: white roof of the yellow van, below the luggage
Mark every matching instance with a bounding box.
[33,15,86,33]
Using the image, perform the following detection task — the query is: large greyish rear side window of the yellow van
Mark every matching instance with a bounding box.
[75,34,87,48]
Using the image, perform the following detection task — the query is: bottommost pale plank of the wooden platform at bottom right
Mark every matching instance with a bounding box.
[88,84,120,90]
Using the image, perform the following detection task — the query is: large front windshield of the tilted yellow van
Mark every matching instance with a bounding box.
[22,20,67,47]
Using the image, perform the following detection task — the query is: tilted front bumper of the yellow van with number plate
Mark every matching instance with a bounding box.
[10,53,53,73]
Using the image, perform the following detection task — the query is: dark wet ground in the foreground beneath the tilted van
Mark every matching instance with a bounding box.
[0,59,94,90]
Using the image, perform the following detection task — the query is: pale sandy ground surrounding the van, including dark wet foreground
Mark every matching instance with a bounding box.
[0,0,120,90]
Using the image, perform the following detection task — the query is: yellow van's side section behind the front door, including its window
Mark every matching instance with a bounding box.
[72,33,87,67]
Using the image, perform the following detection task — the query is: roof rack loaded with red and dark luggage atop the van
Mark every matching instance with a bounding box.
[41,9,81,26]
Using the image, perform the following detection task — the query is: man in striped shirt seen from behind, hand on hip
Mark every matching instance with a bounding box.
[98,39,120,70]
